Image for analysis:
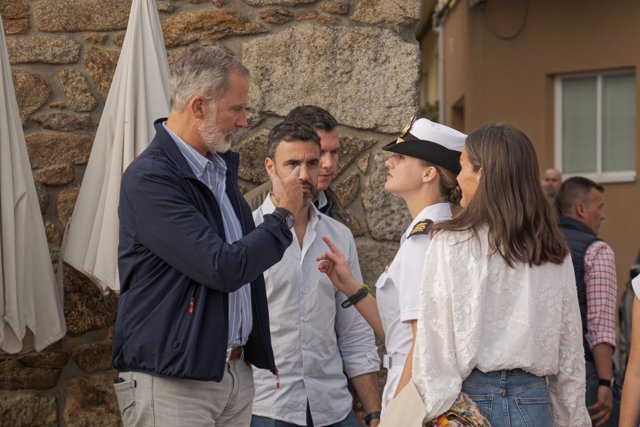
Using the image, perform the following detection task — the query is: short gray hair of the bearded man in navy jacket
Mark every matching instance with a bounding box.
[170,46,249,111]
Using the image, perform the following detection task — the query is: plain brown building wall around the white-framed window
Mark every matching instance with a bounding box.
[443,0,640,291]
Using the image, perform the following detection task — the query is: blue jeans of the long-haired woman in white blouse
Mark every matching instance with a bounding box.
[462,369,553,427]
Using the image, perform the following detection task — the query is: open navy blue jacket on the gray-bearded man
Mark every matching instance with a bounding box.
[113,119,292,381]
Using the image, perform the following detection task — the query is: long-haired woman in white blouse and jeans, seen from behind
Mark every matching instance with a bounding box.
[413,125,591,427]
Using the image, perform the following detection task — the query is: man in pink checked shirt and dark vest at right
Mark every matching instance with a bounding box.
[556,177,620,427]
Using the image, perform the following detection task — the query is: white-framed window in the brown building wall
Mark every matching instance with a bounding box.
[555,70,637,182]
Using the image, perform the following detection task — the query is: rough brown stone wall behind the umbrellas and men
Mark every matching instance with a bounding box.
[0,0,421,426]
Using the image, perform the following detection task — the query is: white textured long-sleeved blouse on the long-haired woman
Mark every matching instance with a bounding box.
[413,230,591,427]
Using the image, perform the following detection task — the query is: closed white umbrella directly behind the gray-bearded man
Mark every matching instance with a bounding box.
[63,0,169,290]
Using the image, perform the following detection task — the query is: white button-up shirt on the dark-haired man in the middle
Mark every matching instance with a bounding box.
[253,197,380,426]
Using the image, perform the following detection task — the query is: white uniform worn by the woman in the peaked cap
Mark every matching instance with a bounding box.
[376,203,451,409]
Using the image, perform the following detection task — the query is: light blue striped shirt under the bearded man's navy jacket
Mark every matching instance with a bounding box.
[162,123,253,347]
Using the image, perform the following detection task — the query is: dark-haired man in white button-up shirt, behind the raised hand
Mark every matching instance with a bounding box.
[251,121,380,427]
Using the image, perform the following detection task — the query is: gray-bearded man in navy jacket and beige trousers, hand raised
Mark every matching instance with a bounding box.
[113,47,302,426]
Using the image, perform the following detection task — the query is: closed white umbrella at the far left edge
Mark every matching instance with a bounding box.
[0,15,66,353]
